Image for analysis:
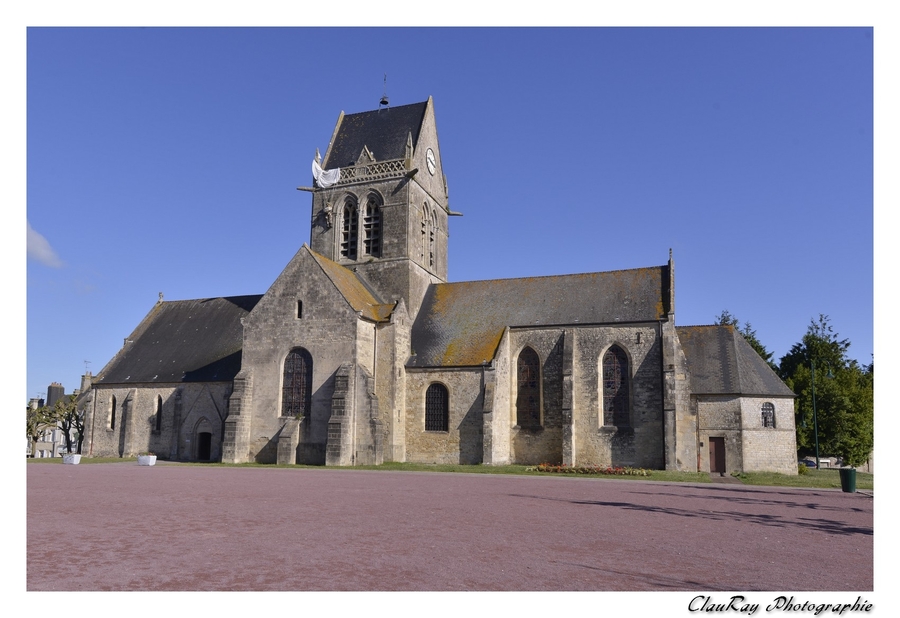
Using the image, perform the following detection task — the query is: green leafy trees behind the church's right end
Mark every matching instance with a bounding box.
[716,311,875,466]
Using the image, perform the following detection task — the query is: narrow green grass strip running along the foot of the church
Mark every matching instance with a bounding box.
[27,457,874,490]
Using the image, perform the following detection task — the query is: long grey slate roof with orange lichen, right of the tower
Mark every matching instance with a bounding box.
[407,266,670,367]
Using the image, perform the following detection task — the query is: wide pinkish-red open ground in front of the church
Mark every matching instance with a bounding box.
[27,463,873,588]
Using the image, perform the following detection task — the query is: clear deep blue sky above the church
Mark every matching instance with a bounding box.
[24,28,873,398]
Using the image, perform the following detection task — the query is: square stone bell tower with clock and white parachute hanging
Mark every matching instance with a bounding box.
[310,97,450,316]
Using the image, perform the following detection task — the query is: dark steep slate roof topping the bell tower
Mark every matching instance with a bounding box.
[322,101,428,169]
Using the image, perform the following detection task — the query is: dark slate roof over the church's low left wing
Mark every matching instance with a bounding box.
[94,295,262,384]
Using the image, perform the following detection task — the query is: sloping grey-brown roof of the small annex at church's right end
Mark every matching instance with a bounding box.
[675,326,794,397]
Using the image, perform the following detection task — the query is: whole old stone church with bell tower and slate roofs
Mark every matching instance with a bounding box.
[80,98,797,474]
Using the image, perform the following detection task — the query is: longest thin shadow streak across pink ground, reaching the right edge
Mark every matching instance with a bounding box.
[509,493,872,536]
